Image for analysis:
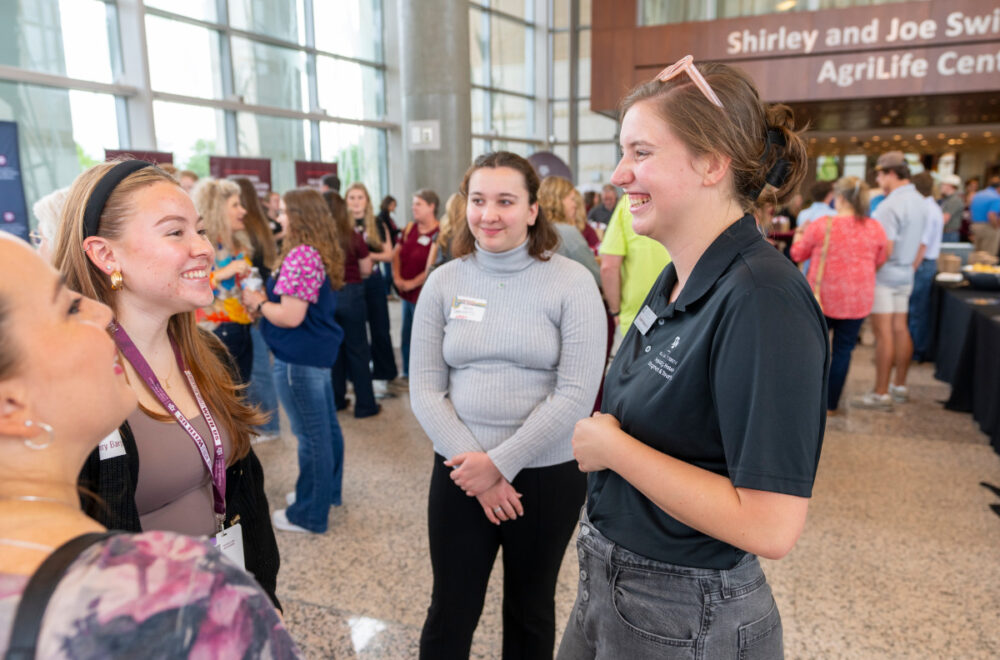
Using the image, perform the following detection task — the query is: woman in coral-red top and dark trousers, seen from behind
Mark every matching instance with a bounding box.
[791,176,888,415]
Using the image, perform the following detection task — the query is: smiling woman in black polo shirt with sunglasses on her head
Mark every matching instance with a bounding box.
[559,57,828,660]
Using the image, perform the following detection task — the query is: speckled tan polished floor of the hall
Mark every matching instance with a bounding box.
[256,305,1000,660]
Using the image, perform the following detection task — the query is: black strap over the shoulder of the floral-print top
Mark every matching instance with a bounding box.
[4,532,117,660]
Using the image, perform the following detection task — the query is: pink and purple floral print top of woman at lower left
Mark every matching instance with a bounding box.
[0,532,300,660]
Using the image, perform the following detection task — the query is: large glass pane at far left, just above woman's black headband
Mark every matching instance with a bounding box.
[0,81,119,217]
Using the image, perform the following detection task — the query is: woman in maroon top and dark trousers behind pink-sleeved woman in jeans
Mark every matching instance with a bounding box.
[323,190,382,418]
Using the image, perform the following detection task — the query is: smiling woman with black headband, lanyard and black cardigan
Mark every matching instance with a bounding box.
[54,160,279,603]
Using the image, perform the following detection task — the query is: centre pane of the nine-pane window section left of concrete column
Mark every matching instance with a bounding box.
[232,37,309,111]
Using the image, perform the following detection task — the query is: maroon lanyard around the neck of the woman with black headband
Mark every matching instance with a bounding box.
[111,322,226,531]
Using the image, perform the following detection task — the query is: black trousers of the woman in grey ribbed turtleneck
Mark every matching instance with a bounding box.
[420,454,587,660]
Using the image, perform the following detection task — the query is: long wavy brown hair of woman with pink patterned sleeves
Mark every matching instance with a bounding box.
[281,188,344,290]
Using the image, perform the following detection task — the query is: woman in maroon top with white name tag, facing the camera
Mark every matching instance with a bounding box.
[392,188,441,378]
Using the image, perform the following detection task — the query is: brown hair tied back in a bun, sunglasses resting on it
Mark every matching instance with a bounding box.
[620,62,807,212]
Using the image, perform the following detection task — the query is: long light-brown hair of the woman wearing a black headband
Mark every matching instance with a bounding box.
[53,161,266,465]
